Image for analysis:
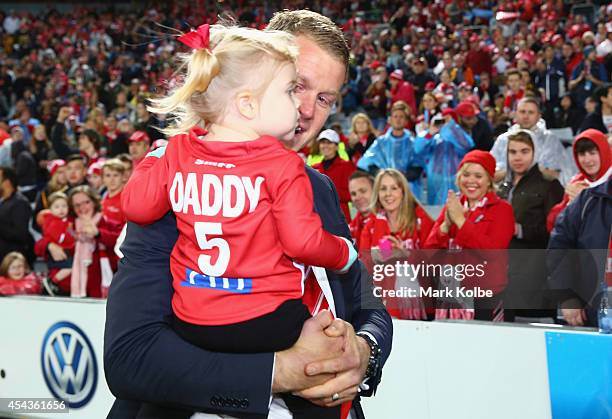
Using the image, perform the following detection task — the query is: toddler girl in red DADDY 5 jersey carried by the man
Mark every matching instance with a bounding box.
[122,25,356,418]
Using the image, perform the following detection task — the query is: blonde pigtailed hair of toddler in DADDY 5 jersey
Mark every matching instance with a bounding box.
[147,25,298,135]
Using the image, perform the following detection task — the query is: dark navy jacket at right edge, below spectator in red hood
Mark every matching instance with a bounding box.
[547,177,612,327]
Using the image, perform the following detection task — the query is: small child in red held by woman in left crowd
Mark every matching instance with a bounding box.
[37,192,75,292]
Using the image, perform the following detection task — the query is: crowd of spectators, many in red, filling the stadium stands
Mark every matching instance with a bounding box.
[0,0,612,326]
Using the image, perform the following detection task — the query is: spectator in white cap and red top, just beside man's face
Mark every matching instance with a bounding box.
[312,129,355,223]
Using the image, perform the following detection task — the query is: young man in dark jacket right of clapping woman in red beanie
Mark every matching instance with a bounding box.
[498,130,563,321]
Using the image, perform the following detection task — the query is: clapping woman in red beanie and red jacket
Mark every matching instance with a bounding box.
[424,150,514,321]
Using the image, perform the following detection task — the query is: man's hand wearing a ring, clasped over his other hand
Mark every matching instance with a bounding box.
[294,319,370,407]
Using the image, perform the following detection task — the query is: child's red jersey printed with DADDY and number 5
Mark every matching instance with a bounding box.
[121,128,348,325]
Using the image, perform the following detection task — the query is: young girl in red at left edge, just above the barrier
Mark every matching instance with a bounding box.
[0,252,40,295]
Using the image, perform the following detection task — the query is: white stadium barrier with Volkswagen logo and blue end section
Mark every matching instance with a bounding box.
[0,297,612,419]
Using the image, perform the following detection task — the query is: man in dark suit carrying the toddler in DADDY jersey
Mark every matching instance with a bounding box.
[104,11,392,419]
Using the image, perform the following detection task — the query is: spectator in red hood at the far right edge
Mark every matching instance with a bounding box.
[546,128,612,232]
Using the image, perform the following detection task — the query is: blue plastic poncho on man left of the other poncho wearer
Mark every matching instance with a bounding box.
[357,128,423,200]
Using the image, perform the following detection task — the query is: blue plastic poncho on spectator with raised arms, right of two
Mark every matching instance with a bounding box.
[414,121,474,205]
